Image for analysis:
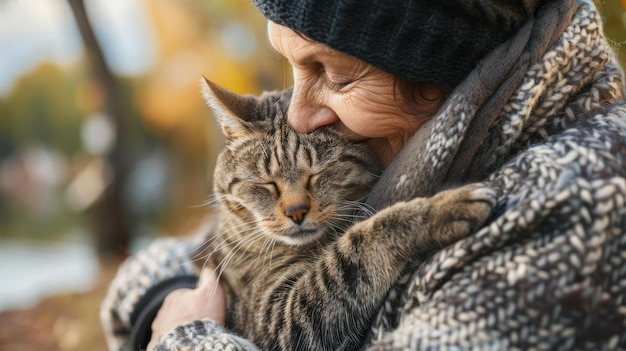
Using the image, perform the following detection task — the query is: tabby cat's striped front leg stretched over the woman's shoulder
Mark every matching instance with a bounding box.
[277,184,496,350]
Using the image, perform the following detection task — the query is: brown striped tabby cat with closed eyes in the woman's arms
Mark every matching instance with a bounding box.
[200,81,494,350]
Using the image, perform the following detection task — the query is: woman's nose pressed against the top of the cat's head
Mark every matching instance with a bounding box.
[287,93,339,133]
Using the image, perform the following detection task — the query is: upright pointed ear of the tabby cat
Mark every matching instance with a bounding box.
[200,77,259,138]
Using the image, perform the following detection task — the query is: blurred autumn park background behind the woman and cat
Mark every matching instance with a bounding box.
[0,0,626,350]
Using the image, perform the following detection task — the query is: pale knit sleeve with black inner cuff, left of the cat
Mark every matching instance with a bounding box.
[100,217,222,350]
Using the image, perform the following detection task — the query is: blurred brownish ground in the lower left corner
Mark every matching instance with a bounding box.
[0,263,117,351]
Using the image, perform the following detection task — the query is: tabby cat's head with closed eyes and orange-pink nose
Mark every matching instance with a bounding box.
[205,78,379,245]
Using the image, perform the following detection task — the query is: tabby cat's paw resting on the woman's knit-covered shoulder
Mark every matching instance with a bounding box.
[428,184,496,243]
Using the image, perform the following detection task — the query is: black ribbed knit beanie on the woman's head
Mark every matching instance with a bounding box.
[253,0,542,87]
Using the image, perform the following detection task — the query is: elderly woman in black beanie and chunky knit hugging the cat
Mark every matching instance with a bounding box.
[102,0,626,350]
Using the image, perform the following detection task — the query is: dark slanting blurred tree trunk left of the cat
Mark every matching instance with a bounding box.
[68,0,131,256]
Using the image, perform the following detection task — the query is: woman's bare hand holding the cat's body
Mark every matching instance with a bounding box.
[147,270,226,350]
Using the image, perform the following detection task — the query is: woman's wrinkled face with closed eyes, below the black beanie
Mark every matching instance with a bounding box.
[268,22,439,166]
